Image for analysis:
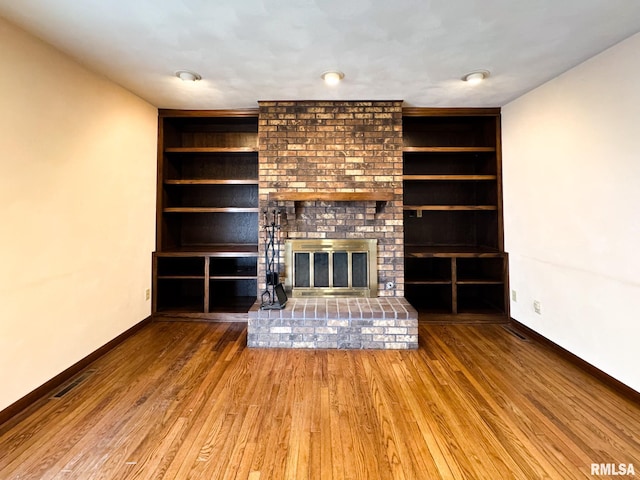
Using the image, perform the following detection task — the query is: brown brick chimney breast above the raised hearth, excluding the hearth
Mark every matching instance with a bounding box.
[258,100,404,297]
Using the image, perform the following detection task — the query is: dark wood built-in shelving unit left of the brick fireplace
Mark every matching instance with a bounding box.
[153,110,258,321]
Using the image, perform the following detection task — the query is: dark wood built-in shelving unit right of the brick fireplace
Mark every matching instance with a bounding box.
[403,108,509,322]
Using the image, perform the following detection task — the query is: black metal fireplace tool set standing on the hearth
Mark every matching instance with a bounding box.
[260,210,287,310]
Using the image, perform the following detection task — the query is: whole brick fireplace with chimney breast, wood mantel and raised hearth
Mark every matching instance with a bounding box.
[249,101,417,348]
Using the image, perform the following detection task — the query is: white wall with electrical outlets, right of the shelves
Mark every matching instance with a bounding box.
[502,34,640,391]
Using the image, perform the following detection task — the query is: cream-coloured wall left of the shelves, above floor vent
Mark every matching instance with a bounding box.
[0,19,157,409]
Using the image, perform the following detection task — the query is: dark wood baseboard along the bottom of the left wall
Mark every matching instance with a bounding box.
[0,316,151,426]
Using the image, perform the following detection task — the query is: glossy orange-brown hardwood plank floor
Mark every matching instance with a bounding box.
[0,322,640,480]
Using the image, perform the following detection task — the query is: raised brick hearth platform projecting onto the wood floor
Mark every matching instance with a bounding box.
[247,297,418,350]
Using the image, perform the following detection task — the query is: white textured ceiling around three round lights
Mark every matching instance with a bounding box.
[0,0,640,109]
